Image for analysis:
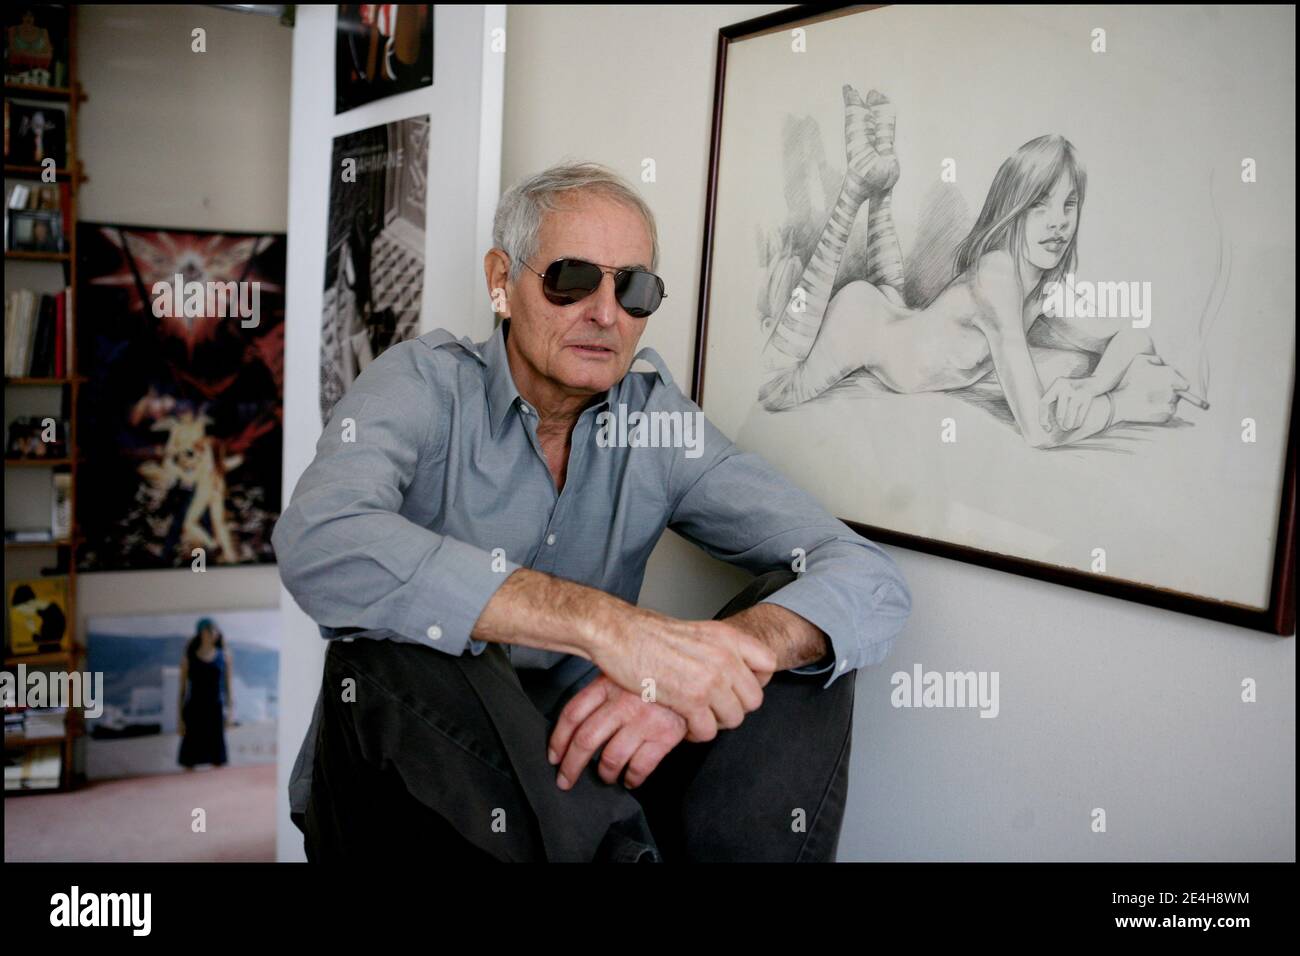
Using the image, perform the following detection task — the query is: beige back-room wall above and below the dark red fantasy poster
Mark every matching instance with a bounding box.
[65,5,293,770]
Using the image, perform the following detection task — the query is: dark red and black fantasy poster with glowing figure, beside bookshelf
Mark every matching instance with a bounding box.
[77,222,285,571]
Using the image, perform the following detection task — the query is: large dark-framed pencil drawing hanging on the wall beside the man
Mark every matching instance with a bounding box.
[693,7,1296,633]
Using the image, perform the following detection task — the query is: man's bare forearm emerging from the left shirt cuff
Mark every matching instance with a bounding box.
[471,567,629,661]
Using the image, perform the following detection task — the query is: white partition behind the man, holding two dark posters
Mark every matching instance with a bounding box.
[277,5,506,861]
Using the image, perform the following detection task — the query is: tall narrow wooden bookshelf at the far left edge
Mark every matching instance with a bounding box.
[4,4,87,797]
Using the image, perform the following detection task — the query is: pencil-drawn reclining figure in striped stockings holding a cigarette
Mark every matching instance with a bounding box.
[759,86,1196,447]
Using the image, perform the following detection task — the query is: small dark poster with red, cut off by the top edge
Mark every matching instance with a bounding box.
[334,4,433,113]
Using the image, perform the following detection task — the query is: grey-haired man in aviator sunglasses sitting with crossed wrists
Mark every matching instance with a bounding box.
[273,164,911,861]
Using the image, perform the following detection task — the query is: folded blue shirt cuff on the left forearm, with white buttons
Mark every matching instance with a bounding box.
[406,537,523,657]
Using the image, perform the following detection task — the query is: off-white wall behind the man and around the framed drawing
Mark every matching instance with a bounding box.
[502,5,1296,861]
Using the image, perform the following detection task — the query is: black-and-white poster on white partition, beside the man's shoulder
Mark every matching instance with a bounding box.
[320,116,429,423]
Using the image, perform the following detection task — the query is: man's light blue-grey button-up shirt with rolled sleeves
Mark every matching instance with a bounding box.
[279,321,911,810]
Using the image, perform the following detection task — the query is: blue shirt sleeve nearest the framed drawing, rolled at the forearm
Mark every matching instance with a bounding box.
[668,405,911,687]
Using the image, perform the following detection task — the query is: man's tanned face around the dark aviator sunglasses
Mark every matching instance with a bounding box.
[507,193,653,395]
